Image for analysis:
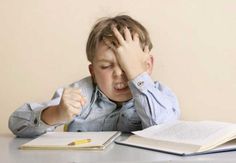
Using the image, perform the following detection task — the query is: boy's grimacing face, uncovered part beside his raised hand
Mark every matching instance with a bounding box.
[89,43,132,102]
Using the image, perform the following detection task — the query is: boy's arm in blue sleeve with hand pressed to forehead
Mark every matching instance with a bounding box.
[109,27,180,128]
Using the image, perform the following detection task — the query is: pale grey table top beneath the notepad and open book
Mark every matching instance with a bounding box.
[0,134,236,163]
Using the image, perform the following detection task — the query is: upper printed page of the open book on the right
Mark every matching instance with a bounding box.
[133,121,236,146]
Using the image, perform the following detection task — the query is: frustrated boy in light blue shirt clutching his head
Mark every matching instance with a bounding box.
[9,15,180,137]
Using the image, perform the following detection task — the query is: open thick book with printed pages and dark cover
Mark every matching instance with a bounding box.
[116,121,236,155]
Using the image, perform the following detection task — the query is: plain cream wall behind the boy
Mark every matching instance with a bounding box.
[0,0,236,132]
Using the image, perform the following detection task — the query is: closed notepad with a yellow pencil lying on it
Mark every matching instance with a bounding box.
[20,131,121,150]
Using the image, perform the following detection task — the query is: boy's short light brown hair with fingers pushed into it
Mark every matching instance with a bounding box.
[86,15,152,62]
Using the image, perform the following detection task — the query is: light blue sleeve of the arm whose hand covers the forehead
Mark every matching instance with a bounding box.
[129,72,180,128]
